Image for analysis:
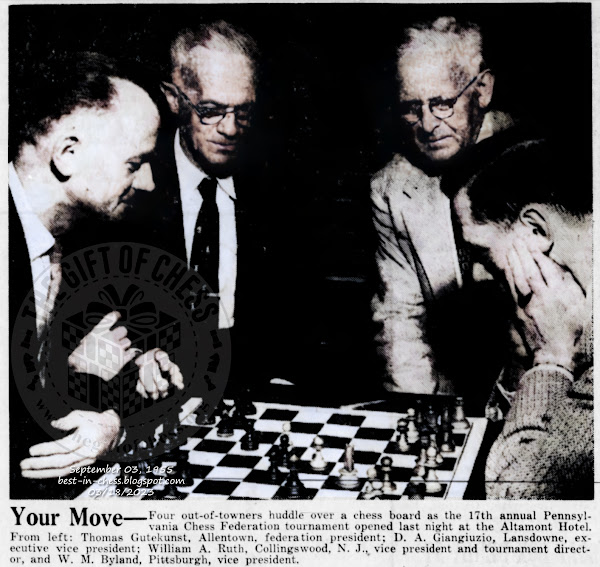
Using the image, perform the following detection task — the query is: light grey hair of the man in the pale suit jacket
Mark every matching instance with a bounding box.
[397,17,486,85]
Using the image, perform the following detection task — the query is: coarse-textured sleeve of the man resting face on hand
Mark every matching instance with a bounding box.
[486,366,594,499]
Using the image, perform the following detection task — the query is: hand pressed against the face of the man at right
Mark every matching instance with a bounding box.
[505,240,589,371]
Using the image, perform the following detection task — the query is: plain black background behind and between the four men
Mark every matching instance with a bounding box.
[9,4,592,401]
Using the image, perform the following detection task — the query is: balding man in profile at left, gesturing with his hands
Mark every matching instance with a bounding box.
[9,54,182,497]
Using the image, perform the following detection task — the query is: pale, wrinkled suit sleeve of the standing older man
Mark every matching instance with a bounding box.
[371,177,437,394]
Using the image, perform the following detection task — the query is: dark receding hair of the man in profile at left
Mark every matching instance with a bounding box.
[10,52,127,151]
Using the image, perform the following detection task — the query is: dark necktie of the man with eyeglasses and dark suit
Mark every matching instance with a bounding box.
[190,177,219,294]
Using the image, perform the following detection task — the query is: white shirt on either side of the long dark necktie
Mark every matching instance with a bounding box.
[175,130,237,329]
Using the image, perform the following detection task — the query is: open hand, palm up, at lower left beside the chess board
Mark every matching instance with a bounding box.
[21,410,121,478]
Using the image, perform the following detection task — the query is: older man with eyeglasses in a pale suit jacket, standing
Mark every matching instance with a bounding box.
[371,18,511,394]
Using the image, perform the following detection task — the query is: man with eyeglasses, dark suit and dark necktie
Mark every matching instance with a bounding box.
[150,21,265,394]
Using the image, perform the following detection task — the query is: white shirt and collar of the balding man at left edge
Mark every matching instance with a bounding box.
[8,163,55,335]
